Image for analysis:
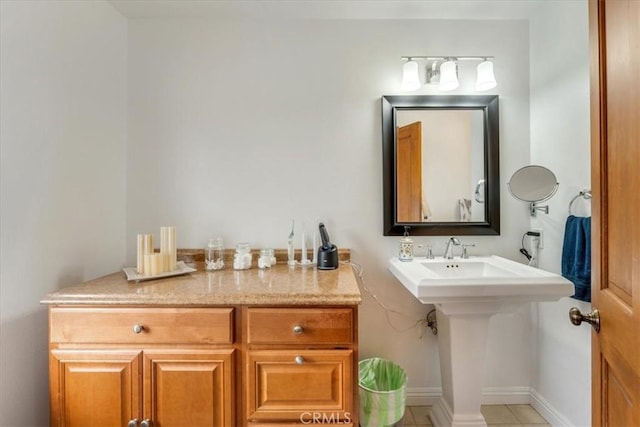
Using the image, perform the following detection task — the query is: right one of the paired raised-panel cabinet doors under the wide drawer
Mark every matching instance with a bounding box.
[143,349,235,427]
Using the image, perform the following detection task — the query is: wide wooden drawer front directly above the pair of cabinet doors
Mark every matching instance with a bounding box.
[49,307,233,344]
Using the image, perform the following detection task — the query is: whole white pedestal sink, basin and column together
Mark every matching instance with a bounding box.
[389,255,574,427]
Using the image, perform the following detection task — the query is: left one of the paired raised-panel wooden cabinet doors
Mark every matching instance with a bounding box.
[49,350,141,427]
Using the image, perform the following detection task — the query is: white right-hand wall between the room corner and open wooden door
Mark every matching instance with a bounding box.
[531,1,591,426]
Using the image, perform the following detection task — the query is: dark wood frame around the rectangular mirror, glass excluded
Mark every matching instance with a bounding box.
[382,95,500,236]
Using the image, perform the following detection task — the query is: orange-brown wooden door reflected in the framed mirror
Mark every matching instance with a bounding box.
[396,122,423,222]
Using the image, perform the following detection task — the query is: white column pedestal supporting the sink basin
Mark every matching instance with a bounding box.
[430,304,504,427]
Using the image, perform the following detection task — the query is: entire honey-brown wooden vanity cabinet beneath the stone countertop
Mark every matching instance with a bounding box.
[49,304,358,427]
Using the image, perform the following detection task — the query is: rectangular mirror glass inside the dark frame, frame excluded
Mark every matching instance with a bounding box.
[396,109,486,223]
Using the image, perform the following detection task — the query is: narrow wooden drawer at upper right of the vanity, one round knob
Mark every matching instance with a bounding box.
[247,308,353,344]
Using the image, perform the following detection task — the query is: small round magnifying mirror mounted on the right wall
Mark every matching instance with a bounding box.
[509,165,558,202]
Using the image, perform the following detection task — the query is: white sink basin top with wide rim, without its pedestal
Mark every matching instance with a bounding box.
[389,255,574,304]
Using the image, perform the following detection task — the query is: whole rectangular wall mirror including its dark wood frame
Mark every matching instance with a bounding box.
[382,95,500,236]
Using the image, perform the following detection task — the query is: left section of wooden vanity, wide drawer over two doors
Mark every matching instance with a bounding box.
[49,307,236,427]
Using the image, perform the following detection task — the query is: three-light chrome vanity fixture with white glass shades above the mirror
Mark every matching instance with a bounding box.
[401,56,497,91]
